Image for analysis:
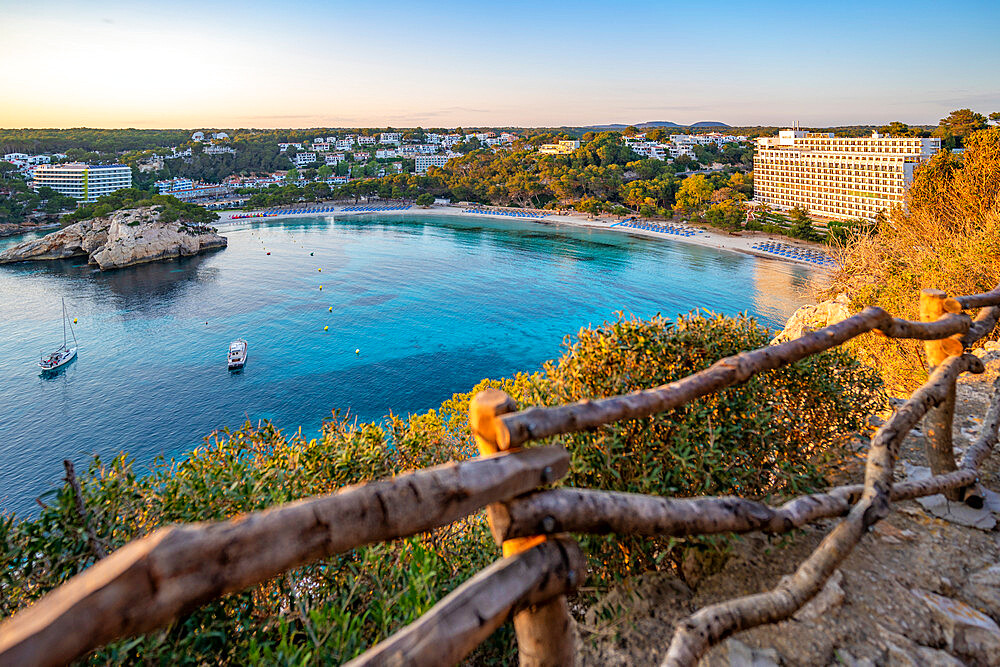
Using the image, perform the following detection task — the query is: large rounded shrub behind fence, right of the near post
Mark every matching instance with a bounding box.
[524,313,883,579]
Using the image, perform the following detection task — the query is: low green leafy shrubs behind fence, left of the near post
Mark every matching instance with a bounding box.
[0,418,513,664]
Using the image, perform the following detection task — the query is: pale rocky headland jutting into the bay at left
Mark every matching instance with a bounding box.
[0,206,227,271]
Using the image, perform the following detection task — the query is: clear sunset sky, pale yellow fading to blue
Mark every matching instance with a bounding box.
[0,0,1000,128]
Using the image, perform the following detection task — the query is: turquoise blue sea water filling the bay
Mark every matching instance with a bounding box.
[0,216,817,514]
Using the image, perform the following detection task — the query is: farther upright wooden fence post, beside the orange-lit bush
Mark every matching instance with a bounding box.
[920,289,964,500]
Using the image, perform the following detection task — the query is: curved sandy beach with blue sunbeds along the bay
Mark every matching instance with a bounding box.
[216,204,829,271]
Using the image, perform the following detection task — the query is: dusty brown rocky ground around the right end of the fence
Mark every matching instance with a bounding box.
[578,354,1000,667]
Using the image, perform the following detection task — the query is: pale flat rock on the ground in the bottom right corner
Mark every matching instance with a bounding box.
[912,588,1000,665]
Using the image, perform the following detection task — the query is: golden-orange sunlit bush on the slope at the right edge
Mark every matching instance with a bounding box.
[831,127,1000,390]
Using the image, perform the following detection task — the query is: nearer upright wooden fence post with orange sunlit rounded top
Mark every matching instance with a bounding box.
[469,388,582,667]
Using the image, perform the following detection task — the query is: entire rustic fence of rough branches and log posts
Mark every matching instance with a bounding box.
[0,286,1000,667]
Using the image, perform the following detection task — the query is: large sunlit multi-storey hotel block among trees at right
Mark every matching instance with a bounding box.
[753,129,941,219]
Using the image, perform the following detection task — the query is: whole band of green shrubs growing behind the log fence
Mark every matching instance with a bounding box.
[0,312,882,664]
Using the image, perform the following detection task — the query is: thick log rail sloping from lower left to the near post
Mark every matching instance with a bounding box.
[0,447,569,665]
